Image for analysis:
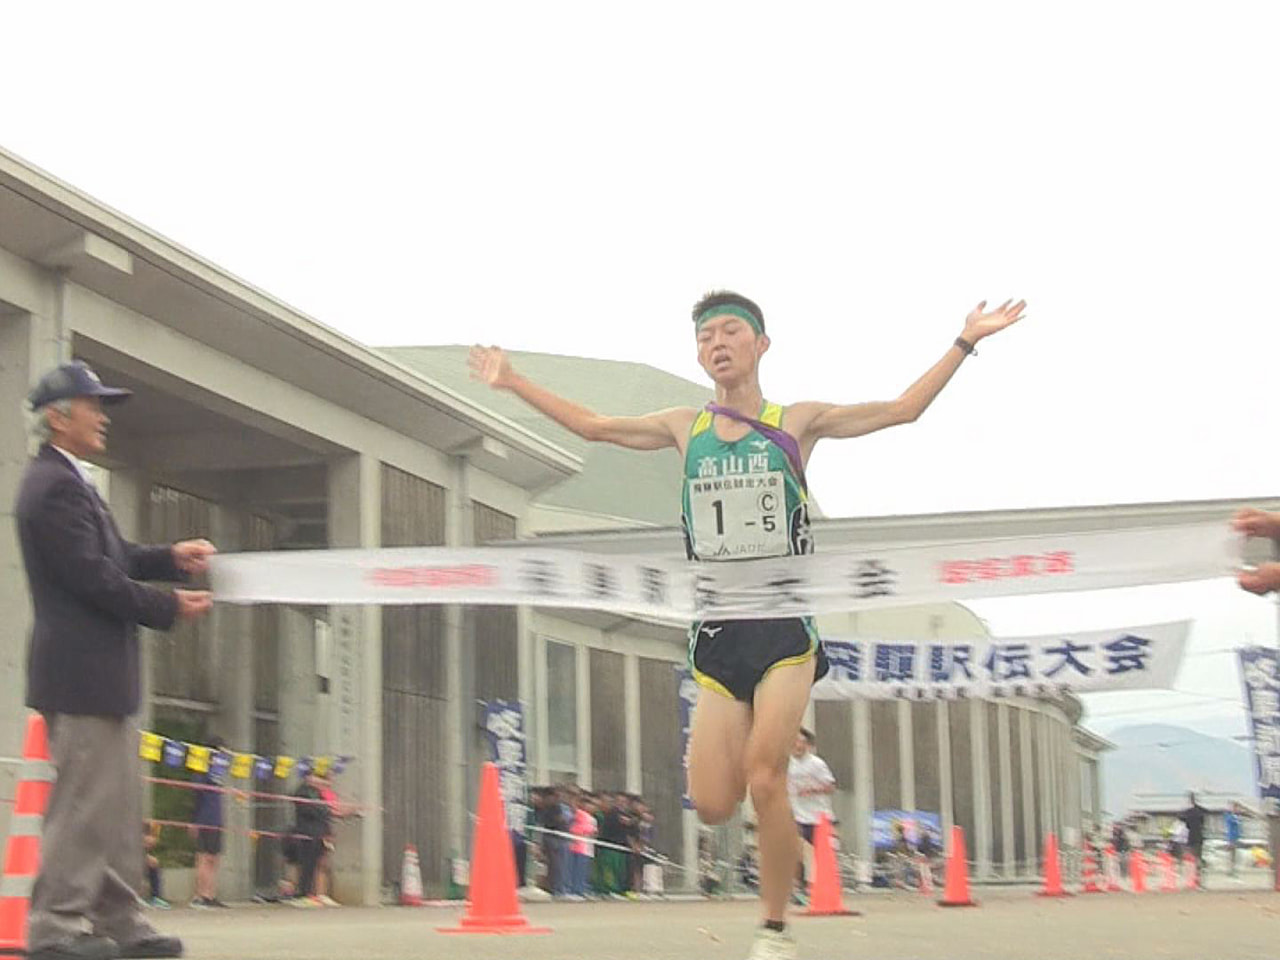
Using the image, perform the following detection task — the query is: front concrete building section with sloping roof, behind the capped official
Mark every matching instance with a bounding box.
[0,146,581,902]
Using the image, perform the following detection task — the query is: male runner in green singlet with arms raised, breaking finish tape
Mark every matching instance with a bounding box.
[470,292,1027,960]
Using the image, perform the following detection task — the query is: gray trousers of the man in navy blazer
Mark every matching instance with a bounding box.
[28,713,155,950]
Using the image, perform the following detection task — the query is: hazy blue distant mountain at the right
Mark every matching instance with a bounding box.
[1102,723,1254,814]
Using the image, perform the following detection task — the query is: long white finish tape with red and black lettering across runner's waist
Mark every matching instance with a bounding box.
[210,524,1240,621]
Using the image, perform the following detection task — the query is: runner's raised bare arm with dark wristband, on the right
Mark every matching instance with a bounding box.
[787,300,1027,457]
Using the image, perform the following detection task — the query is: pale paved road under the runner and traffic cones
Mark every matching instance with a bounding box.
[145,891,1280,960]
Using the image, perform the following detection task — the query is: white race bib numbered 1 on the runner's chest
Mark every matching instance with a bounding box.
[689,470,788,559]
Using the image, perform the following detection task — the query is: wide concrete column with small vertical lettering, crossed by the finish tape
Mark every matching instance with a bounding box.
[329,453,383,906]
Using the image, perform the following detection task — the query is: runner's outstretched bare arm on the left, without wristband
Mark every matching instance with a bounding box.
[467,346,694,451]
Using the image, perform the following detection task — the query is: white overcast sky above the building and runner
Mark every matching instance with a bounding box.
[0,1,1280,737]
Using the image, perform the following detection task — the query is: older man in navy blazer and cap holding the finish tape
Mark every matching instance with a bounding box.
[15,364,215,960]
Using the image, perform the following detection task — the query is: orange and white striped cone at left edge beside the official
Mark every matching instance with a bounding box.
[0,713,54,956]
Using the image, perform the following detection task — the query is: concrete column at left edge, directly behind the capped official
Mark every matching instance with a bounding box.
[0,314,70,836]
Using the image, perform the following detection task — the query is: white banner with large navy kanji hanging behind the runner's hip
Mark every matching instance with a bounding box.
[813,621,1190,700]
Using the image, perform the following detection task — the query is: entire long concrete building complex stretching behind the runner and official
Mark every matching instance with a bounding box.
[0,152,1264,902]
